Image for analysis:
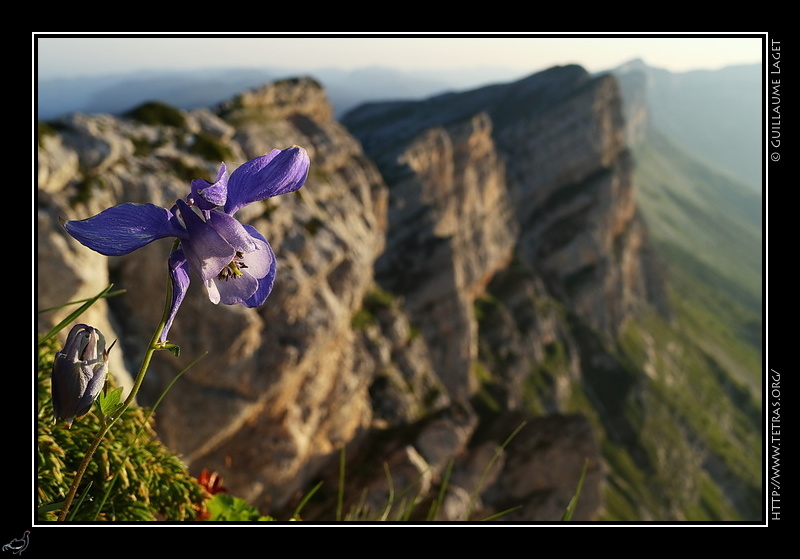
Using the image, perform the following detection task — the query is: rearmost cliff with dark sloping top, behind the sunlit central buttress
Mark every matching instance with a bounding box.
[343,66,668,344]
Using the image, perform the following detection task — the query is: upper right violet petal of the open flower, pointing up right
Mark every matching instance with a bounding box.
[225,146,309,215]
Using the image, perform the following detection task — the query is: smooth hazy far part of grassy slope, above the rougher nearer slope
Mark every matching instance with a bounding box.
[635,129,763,390]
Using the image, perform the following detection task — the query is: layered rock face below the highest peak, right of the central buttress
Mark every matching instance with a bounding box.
[498,71,667,333]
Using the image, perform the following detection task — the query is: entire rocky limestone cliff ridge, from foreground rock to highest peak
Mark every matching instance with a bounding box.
[37,67,756,520]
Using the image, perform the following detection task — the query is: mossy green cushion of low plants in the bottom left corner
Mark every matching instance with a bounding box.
[36,339,209,522]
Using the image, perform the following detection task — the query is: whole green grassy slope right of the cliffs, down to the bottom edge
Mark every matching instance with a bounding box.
[604,128,763,520]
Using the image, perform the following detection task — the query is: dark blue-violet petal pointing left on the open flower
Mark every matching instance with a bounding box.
[64,203,186,256]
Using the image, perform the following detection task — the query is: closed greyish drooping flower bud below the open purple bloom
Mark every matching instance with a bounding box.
[51,324,116,427]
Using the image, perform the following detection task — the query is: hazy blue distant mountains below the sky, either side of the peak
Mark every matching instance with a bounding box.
[36,60,762,195]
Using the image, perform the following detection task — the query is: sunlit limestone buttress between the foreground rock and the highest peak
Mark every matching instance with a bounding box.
[376,114,516,398]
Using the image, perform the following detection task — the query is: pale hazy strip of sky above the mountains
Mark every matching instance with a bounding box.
[33,32,765,79]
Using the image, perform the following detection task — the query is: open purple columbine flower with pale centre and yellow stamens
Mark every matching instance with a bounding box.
[64,146,309,342]
